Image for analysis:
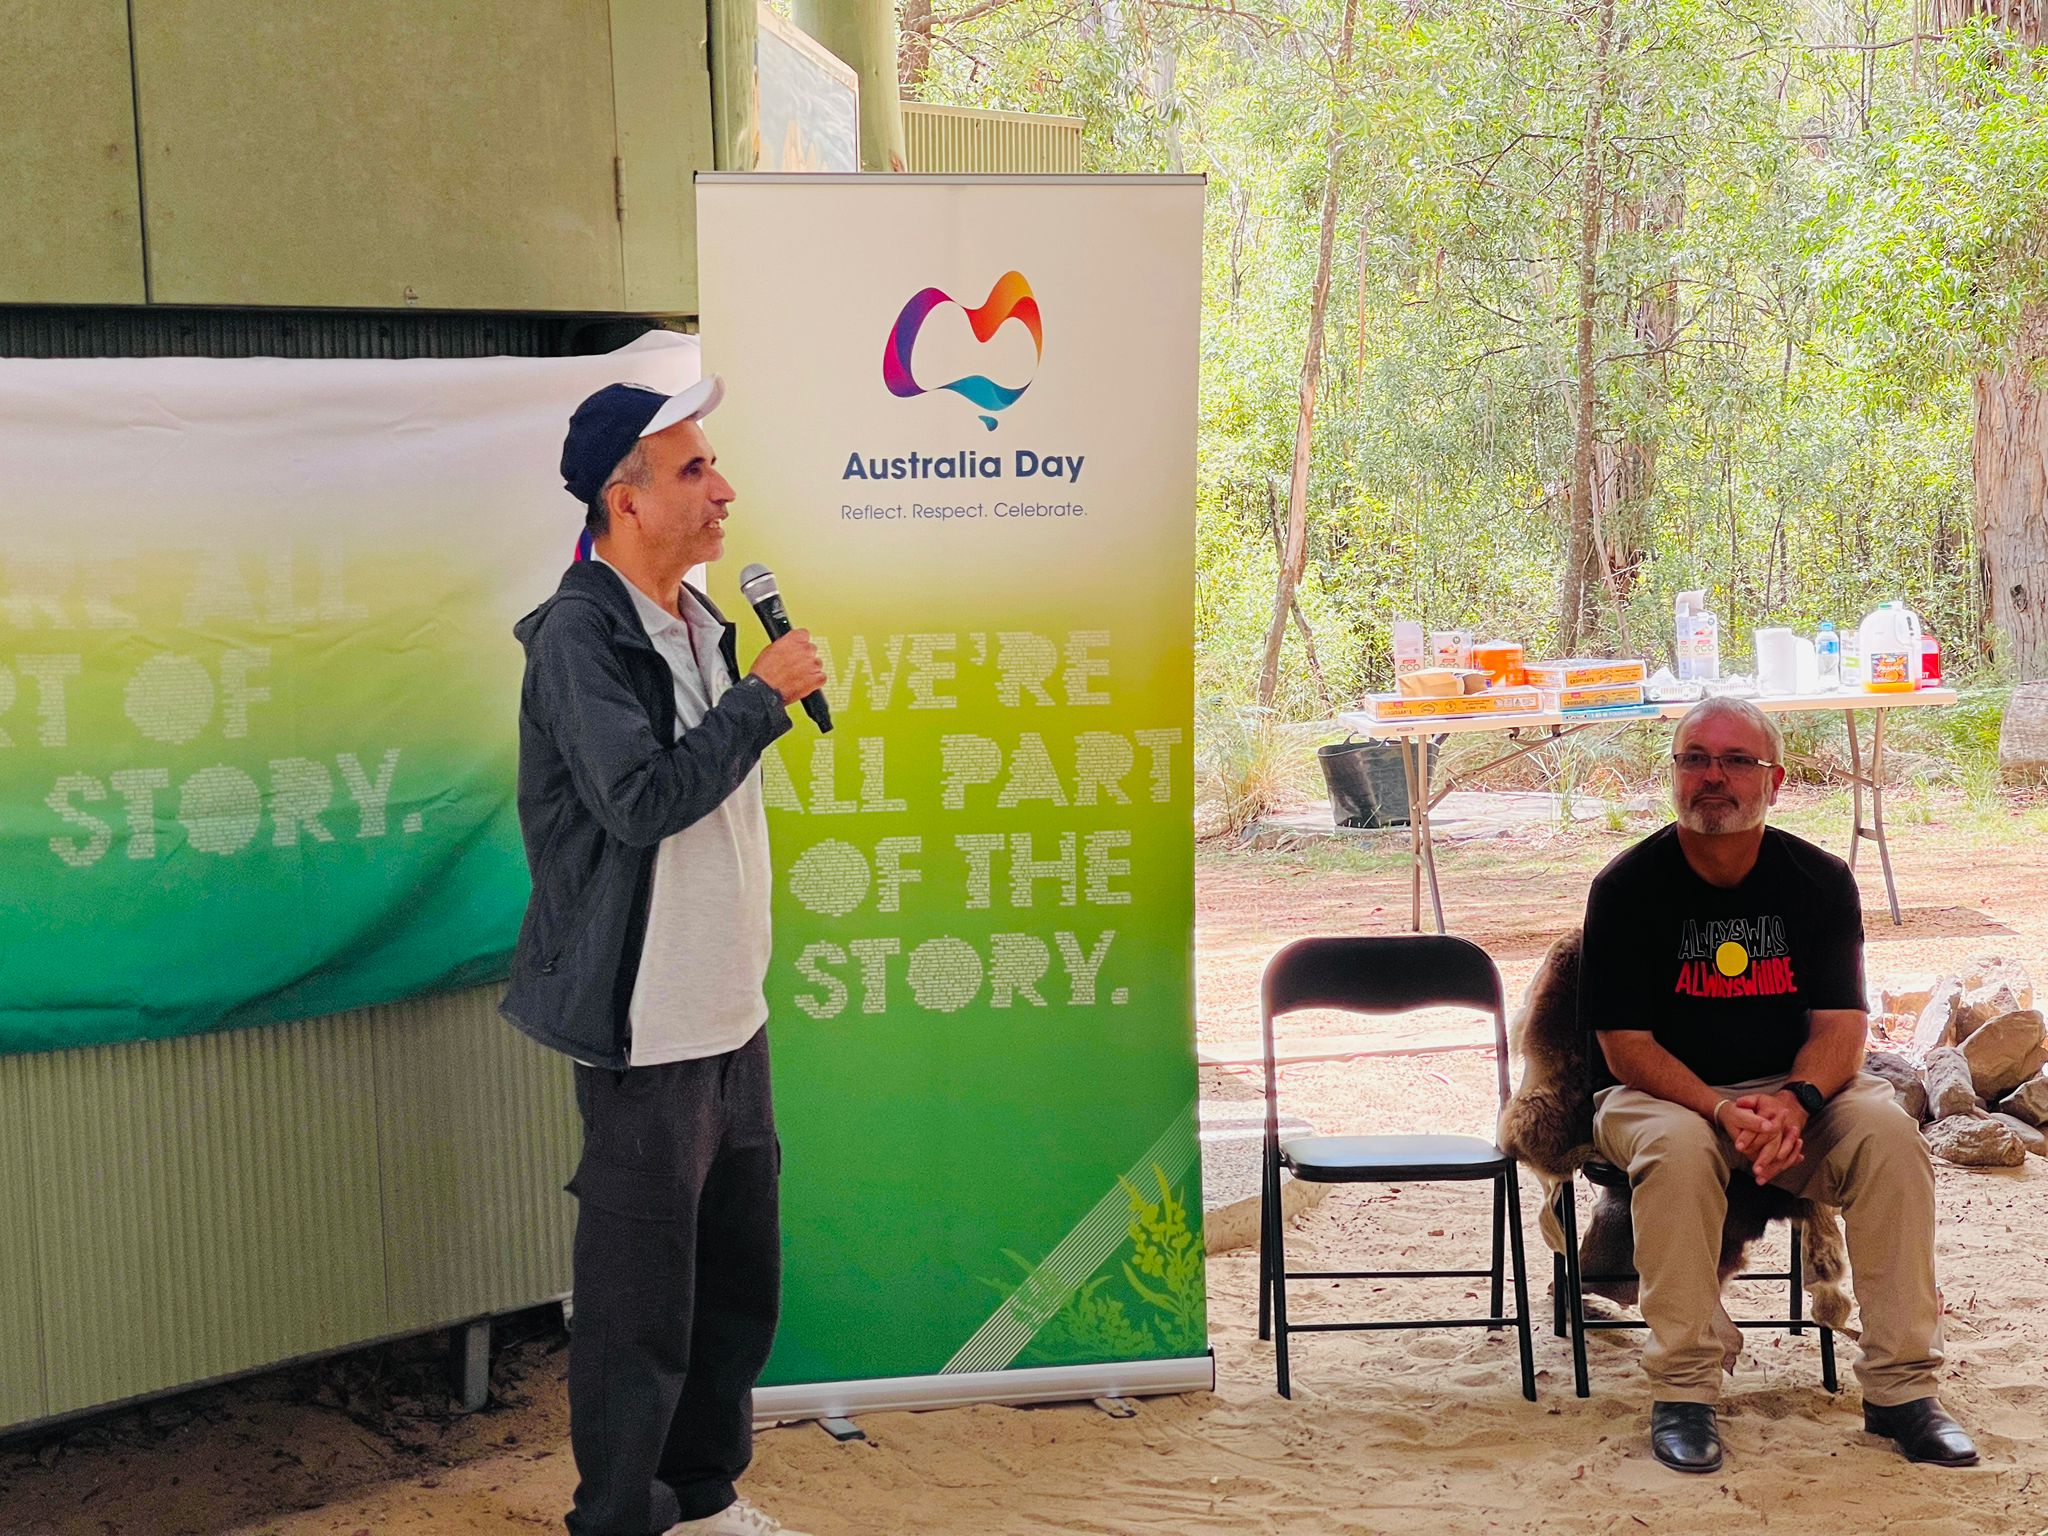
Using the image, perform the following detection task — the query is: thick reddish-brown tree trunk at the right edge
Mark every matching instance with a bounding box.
[1970,303,2048,680]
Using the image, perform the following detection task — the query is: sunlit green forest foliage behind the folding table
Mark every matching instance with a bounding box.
[915,0,2048,716]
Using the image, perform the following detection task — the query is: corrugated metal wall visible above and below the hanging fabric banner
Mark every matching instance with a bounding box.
[0,307,589,1427]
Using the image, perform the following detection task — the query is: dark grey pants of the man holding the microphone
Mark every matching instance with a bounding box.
[569,1030,782,1536]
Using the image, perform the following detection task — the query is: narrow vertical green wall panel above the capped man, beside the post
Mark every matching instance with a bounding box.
[610,0,713,315]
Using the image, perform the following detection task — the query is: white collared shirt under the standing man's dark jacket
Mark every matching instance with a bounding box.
[594,555,772,1067]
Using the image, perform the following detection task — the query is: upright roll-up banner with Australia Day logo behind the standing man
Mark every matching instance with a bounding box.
[696,176,1212,1415]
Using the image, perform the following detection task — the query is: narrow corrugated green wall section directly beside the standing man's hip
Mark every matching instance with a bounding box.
[367,985,582,1331]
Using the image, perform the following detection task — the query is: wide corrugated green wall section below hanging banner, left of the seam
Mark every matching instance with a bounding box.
[27,1018,389,1413]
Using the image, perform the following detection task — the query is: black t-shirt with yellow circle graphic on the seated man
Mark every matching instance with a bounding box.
[1579,827,1870,1085]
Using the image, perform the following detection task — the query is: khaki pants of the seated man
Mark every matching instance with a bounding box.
[1593,1073,1942,1407]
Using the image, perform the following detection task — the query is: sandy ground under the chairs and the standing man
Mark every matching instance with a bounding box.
[0,798,2048,1536]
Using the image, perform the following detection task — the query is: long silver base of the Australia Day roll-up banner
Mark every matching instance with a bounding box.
[754,1354,1217,1430]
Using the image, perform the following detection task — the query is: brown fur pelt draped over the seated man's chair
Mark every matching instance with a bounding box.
[1499,928,1849,1329]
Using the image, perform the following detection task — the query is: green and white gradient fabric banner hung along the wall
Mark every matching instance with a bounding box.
[0,338,698,1053]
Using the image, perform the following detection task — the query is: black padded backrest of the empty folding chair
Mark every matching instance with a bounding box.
[1260,934,1507,1118]
